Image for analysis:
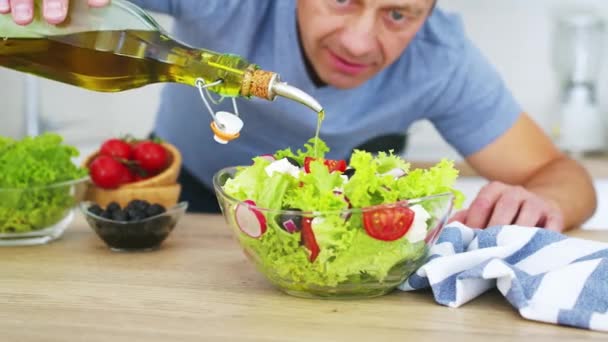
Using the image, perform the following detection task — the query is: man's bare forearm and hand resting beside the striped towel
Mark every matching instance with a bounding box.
[456,113,597,231]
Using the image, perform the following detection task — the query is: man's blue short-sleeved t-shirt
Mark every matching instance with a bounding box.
[133,0,522,186]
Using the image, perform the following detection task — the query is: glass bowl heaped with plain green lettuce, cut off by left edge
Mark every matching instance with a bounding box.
[0,133,88,246]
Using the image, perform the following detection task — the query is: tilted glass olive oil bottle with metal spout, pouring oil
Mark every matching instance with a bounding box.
[0,0,324,154]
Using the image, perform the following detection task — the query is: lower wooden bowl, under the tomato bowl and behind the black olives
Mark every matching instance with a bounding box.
[85,183,181,208]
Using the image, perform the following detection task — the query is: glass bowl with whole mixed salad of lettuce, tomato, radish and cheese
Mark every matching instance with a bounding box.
[213,139,463,298]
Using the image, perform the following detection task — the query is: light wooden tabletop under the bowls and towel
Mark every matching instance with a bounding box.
[0,215,608,342]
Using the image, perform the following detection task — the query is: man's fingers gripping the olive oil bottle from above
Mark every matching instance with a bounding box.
[0,0,110,25]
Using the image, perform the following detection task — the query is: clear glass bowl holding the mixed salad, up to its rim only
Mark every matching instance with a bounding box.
[213,167,454,298]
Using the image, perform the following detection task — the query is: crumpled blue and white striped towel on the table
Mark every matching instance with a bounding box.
[399,223,608,331]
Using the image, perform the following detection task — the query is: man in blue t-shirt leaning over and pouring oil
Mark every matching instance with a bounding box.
[0,0,596,231]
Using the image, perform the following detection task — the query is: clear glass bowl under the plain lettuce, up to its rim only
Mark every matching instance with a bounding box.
[0,177,88,246]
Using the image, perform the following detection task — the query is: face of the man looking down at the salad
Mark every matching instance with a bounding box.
[297,0,434,89]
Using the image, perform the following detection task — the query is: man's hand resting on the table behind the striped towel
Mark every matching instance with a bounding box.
[451,182,565,232]
